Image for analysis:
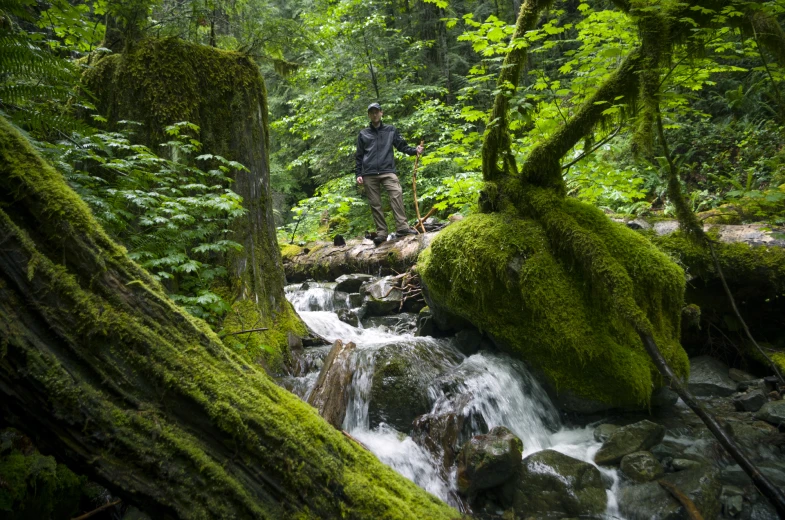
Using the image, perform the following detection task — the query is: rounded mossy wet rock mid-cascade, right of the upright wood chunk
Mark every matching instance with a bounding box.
[368,344,438,433]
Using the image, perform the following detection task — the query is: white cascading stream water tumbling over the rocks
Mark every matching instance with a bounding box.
[283,282,619,518]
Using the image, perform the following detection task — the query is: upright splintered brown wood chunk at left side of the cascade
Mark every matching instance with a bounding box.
[308,340,355,429]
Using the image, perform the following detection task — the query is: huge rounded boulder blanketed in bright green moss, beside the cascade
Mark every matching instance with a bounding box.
[419,205,689,412]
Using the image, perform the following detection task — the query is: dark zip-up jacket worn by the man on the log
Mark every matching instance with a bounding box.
[354,123,417,177]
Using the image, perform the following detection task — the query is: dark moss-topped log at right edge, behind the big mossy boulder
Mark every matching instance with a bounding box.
[651,232,785,372]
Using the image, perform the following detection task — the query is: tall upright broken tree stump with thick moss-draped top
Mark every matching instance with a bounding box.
[83,38,305,370]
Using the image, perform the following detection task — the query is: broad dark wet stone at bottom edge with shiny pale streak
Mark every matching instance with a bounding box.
[513,450,608,518]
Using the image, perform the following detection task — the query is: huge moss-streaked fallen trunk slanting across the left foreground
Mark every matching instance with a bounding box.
[0,118,458,520]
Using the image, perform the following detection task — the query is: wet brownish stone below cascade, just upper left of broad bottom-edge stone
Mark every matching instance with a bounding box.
[457,426,523,496]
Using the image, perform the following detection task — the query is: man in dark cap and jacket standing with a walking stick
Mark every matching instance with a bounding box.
[355,103,423,245]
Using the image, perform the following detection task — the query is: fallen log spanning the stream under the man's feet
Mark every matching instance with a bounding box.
[282,232,437,283]
